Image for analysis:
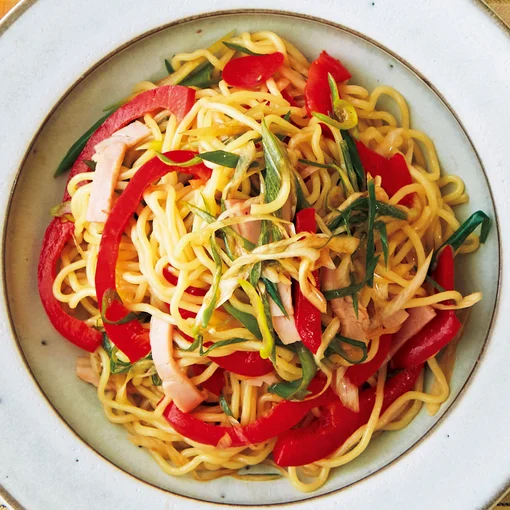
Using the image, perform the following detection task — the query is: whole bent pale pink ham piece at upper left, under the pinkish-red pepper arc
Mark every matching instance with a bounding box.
[86,121,151,223]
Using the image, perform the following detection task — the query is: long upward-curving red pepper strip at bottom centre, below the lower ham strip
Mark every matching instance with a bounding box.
[163,378,335,447]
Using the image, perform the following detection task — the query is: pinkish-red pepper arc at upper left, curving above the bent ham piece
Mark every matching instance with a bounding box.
[63,85,195,202]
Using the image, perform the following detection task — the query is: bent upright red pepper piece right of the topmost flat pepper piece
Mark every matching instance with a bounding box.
[305,51,351,116]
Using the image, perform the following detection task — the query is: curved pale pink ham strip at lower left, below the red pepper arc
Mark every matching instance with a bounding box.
[150,316,205,413]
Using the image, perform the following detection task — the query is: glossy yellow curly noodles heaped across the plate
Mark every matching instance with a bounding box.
[46,31,481,492]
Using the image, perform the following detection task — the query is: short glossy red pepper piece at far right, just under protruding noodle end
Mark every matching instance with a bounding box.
[391,310,462,368]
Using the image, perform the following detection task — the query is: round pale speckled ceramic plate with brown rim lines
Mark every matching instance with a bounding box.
[0,0,510,510]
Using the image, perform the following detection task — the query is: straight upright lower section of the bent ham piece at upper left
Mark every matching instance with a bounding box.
[86,142,127,223]
